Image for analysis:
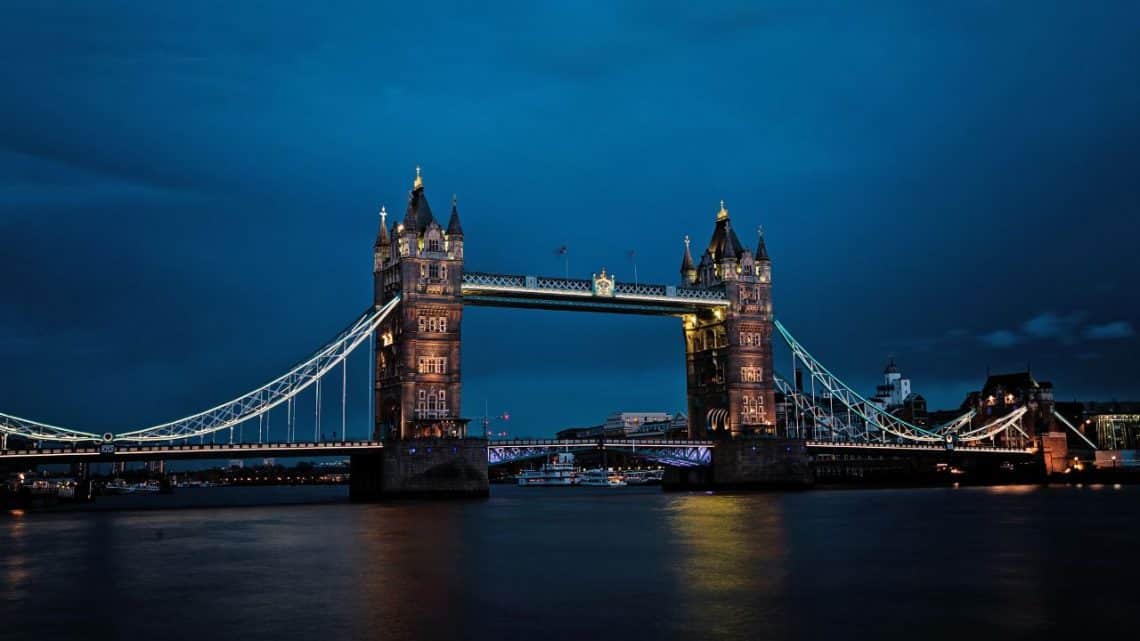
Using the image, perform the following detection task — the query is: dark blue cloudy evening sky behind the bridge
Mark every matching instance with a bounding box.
[0,1,1140,433]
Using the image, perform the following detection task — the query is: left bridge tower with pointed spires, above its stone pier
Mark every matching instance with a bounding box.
[373,167,469,439]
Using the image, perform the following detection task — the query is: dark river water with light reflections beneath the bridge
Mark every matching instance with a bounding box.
[0,486,1140,641]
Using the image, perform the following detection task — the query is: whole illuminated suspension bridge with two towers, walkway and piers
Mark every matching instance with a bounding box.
[0,168,1065,497]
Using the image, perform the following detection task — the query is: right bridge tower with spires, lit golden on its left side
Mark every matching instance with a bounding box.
[681,201,775,438]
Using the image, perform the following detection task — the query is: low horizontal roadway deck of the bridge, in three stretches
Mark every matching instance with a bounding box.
[0,438,1036,463]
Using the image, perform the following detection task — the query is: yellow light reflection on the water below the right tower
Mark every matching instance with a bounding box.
[668,494,789,639]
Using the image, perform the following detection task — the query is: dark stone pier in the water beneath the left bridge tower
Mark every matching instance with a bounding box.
[349,438,489,501]
